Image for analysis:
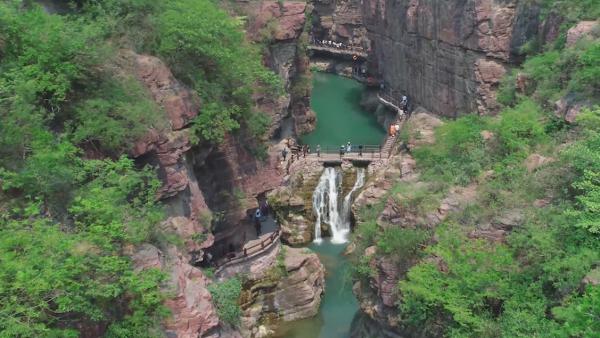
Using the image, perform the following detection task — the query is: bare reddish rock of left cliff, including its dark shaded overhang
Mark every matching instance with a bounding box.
[123,46,296,337]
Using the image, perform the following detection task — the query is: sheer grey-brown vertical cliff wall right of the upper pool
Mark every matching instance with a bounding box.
[363,0,540,116]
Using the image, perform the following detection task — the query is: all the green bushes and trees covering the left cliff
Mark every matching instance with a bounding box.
[0,0,282,337]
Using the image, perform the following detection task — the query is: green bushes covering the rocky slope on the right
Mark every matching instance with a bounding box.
[355,19,600,337]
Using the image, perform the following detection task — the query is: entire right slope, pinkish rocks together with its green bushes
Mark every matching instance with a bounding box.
[346,1,600,337]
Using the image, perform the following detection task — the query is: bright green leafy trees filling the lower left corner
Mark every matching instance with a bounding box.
[0,158,165,336]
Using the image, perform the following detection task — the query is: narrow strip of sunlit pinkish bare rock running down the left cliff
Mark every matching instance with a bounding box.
[124,52,239,338]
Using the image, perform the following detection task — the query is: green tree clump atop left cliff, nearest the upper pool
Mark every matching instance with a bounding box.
[158,0,279,142]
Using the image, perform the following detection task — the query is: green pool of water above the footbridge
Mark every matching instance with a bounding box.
[300,72,385,149]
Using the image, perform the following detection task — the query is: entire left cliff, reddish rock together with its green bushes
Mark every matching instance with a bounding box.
[0,0,314,337]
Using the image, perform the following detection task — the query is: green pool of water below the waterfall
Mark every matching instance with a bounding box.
[275,238,358,338]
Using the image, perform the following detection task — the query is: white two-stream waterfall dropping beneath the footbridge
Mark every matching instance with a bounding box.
[313,167,365,243]
